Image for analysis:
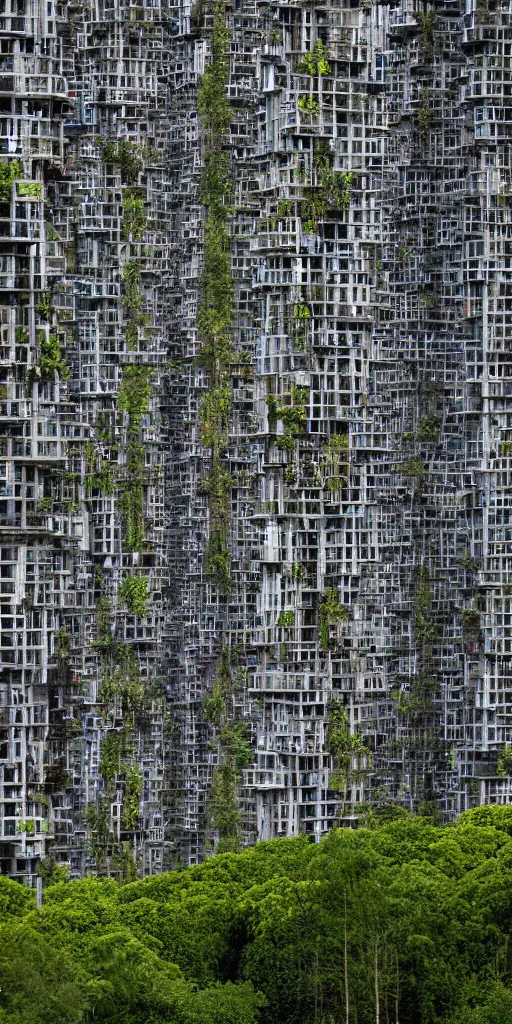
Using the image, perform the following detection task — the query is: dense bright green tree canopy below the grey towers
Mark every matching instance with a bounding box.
[0,807,512,1024]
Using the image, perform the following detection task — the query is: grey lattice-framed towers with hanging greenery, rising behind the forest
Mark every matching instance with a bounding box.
[0,0,512,884]
